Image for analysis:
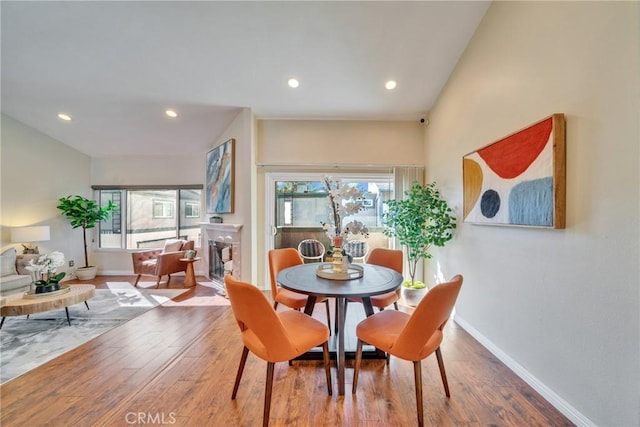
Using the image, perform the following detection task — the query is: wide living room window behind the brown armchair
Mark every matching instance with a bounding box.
[94,185,202,249]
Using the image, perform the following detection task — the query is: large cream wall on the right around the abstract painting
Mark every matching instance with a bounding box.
[426,2,640,426]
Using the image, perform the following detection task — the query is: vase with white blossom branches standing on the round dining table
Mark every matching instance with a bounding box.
[321,177,369,272]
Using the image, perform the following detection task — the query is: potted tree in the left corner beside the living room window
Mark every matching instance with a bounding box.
[57,196,117,280]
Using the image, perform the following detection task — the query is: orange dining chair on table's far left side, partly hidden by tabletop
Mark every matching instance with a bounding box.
[269,248,331,329]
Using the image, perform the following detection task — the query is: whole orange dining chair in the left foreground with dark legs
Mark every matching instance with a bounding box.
[224,274,331,426]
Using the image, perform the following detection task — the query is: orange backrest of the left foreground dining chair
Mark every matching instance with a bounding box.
[224,274,296,362]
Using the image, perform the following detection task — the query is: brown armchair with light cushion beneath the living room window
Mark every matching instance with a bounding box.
[131,239,195,288]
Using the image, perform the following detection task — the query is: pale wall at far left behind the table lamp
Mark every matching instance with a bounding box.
[0,115,91,271]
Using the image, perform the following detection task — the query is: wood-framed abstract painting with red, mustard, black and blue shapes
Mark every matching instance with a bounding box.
[462,114,565,228]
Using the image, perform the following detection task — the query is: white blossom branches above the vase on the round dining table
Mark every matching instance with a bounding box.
[321,177,369,241]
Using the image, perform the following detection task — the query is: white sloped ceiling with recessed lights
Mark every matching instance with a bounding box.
[0,0,489,157]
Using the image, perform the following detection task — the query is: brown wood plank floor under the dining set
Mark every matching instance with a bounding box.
[0,276,573,427]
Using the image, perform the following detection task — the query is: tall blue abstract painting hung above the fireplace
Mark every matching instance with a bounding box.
[206,139,235,214]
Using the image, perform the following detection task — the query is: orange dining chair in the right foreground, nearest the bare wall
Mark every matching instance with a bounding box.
[352,275,462,426]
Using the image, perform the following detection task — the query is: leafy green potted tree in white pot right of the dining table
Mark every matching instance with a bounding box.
[383,182,456,305]
